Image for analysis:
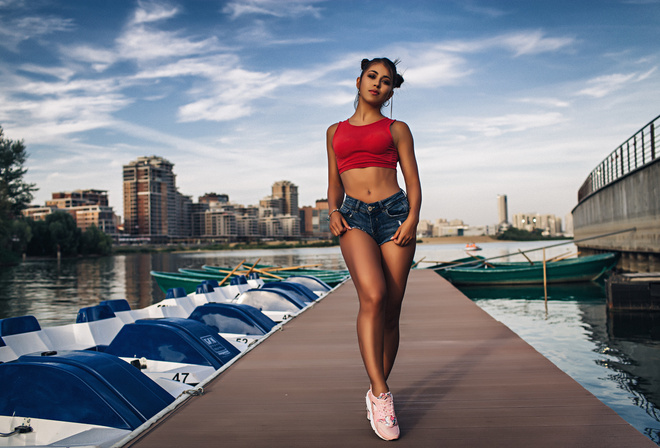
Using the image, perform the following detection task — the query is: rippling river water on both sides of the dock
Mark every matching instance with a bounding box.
[0,242,660,445]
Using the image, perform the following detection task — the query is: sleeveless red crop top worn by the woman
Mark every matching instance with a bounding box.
[332,118,399,174]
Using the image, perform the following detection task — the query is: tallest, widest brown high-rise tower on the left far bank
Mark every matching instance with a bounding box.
[124,156,192,242]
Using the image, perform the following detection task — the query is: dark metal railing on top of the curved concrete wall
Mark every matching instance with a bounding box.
[578,115,660,203]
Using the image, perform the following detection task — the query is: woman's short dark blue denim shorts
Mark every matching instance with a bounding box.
[339,190,410,246]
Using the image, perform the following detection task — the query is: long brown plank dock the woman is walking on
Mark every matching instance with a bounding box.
[125,270,657,448]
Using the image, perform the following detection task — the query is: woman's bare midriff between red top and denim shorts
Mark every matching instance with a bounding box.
[341,166,401,204]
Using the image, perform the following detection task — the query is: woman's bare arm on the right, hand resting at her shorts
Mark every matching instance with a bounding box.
[392,121,422,246]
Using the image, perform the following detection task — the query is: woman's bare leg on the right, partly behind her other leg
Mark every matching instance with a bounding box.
[380,242,415,380]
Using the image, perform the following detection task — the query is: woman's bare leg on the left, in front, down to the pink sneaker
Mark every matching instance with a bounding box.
[339,229,389,396]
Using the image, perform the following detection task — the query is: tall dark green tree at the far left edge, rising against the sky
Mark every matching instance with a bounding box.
[0,126,37,219]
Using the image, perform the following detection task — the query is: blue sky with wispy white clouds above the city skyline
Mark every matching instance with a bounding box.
[0,0,660,225]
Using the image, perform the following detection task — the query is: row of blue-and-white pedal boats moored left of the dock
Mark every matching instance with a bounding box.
[0,274,340,447]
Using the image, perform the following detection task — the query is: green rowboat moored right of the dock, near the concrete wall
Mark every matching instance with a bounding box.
[431,253,619,285]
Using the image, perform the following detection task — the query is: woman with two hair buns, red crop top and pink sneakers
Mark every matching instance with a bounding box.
[327,58,422,440]
